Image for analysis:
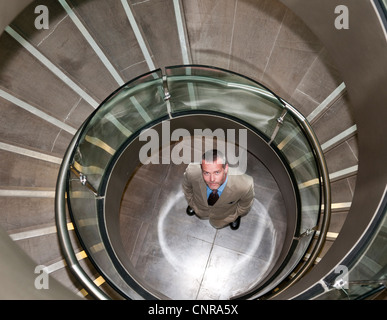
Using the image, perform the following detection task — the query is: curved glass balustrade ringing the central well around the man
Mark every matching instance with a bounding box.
[57,66,330,299]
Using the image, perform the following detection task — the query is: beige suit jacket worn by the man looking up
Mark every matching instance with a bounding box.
[183,163,255,228]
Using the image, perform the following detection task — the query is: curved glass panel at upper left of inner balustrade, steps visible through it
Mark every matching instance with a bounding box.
[73,70,168,190]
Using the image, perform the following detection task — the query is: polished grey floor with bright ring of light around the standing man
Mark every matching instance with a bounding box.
[120,149,286,300]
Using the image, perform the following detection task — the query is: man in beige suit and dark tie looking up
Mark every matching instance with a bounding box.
[183,150,254,230]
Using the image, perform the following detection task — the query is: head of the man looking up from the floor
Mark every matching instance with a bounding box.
[201,149,228,190]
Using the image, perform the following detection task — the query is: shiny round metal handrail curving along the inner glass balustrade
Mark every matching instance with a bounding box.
[56,65,331,299]
